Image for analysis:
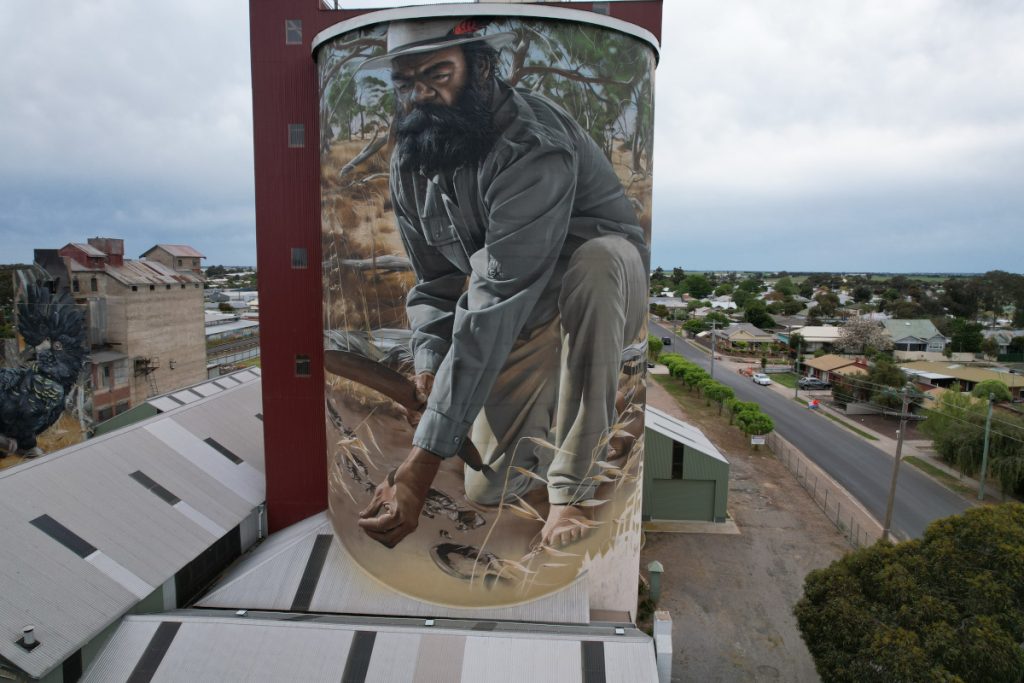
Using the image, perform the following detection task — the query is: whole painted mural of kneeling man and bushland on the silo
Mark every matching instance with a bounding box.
[316,16,654,607]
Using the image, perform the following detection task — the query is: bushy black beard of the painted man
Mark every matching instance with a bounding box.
[395,76,497,175]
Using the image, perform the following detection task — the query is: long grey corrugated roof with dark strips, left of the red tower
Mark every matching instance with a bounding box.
[0,373,264,678]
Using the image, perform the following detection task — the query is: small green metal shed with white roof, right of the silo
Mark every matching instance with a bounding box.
[643,407,729,522]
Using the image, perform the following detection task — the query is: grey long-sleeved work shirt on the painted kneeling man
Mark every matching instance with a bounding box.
[391,84,649,458]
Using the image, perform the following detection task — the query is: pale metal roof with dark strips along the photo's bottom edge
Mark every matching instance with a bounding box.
[82,610,657,683]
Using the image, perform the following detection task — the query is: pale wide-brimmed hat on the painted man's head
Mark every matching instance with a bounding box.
[359,18,515,70]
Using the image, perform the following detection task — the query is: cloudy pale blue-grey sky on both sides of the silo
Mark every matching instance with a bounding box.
[0,0,1024,272]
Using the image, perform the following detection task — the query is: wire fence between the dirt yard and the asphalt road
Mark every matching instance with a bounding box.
[766,432,882,548]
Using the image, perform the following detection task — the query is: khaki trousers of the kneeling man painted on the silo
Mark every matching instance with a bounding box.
[465,236,647,505]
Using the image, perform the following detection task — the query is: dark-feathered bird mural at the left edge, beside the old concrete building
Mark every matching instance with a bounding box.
[0,284,89,457]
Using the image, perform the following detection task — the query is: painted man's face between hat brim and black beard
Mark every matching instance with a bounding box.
[391,45,469,112]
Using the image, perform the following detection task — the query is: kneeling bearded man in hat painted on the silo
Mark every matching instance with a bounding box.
[358,19,649,547]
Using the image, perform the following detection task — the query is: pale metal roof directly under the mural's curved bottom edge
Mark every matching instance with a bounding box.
[197,513,590,624]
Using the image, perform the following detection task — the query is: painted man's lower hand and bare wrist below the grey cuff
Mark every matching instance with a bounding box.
[358,446,441,548]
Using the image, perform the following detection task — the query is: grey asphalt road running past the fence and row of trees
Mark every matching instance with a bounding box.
[650,323,971,539]
